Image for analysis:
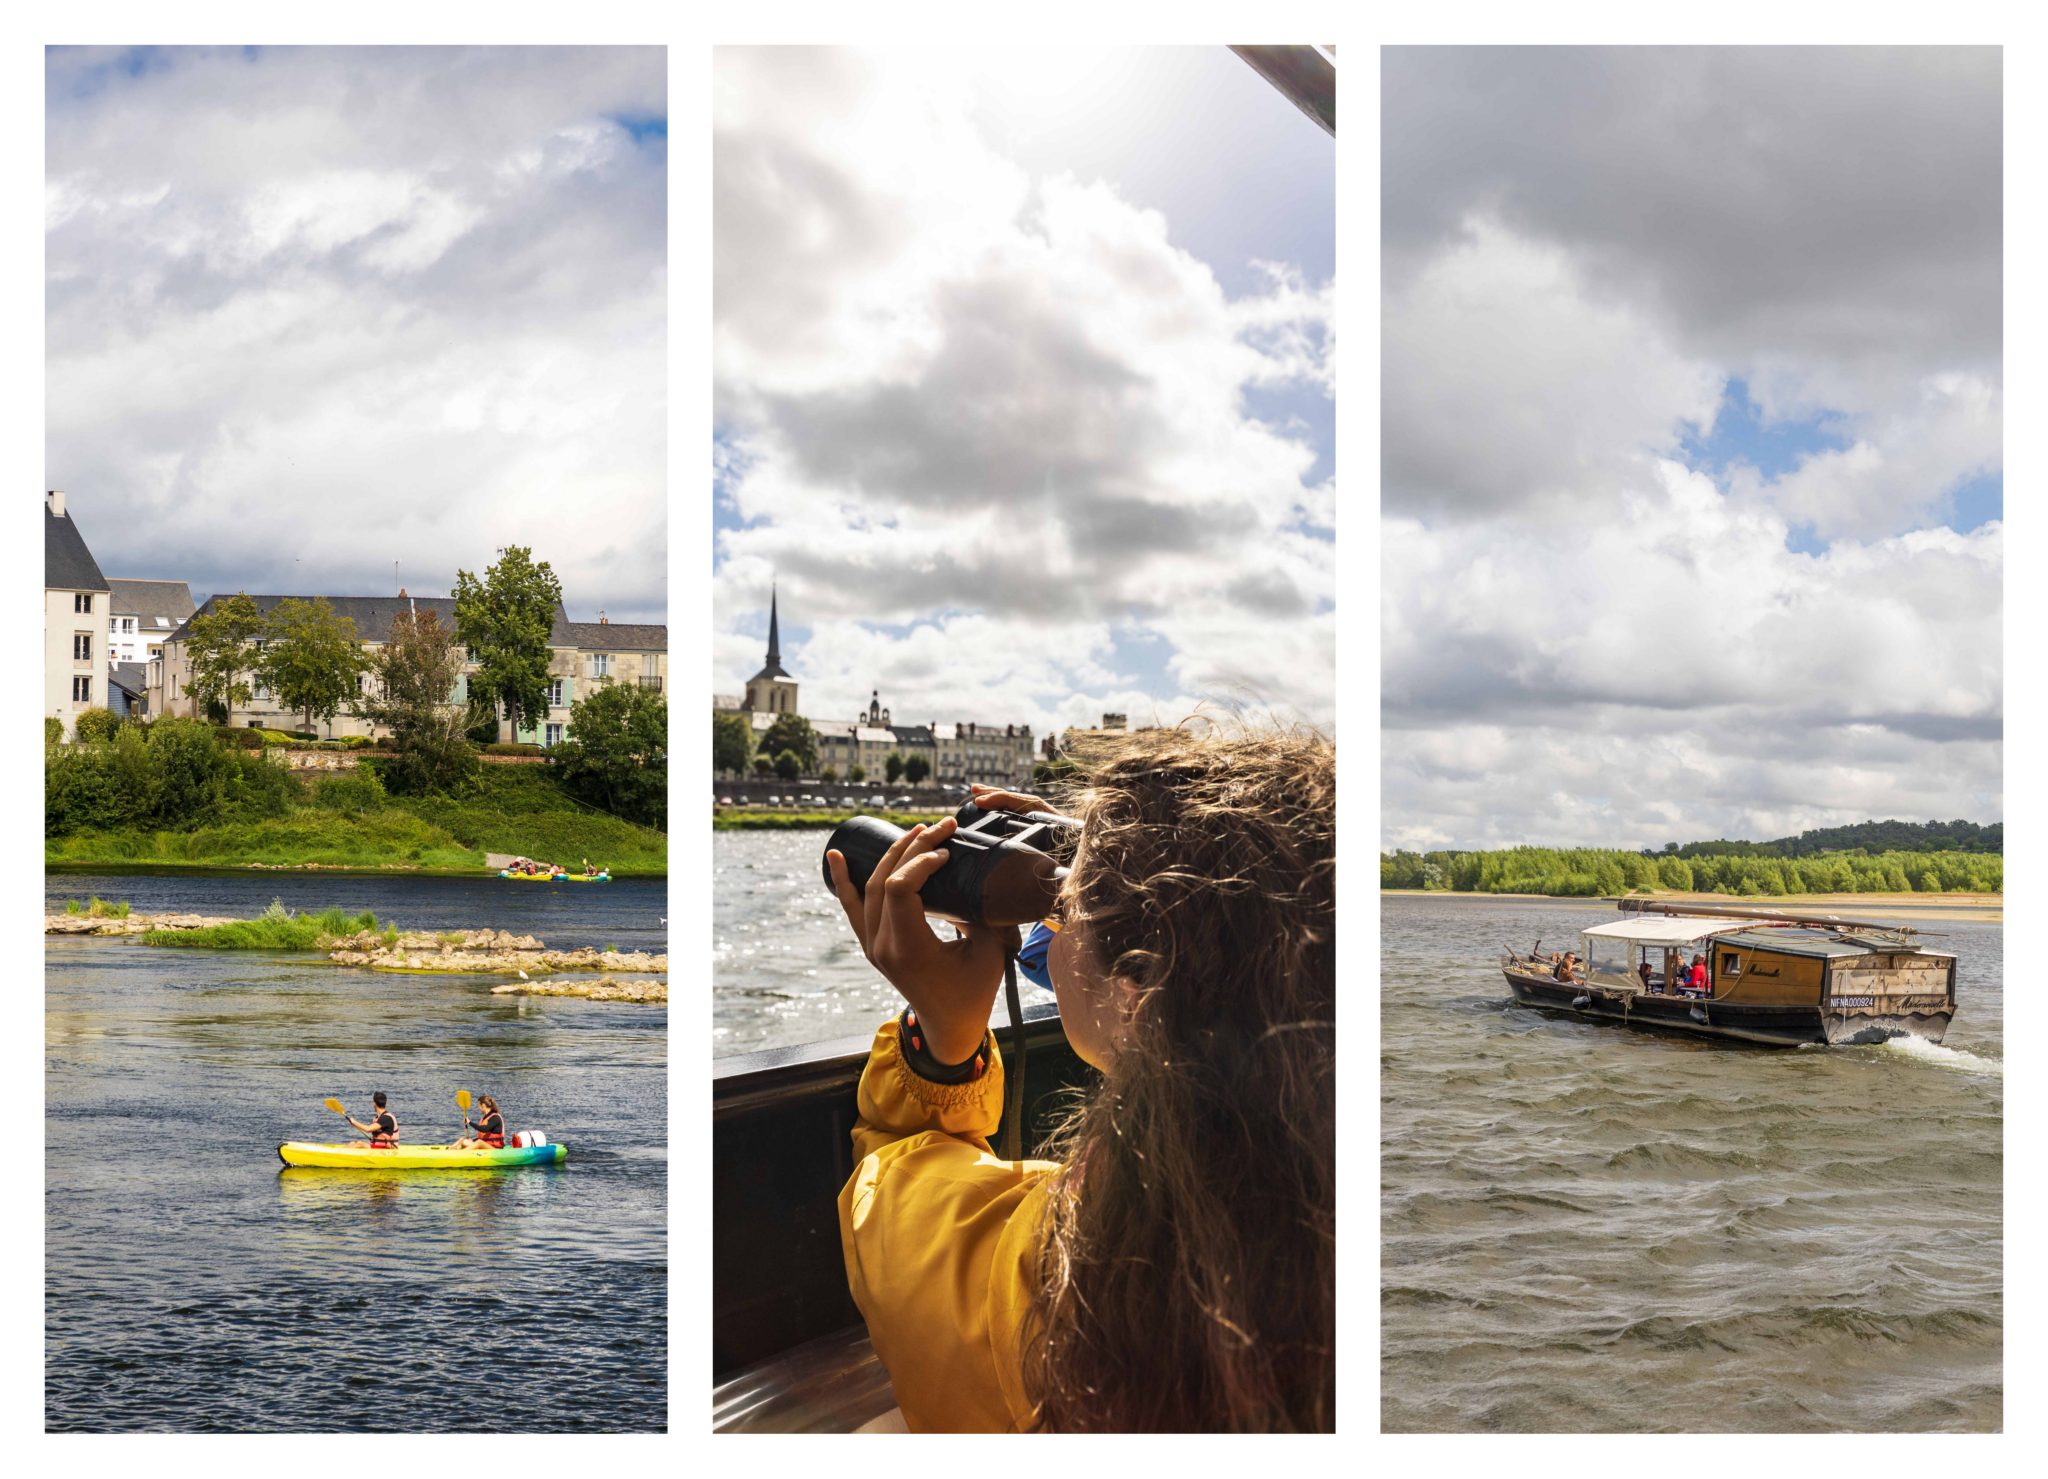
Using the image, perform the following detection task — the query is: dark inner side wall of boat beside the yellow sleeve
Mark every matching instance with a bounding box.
[711,1002,1092,1381]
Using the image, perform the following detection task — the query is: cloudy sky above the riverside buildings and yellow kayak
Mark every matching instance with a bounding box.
[43,47,668,621]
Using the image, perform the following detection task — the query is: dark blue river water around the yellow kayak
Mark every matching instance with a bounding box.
[45,875,668,1432]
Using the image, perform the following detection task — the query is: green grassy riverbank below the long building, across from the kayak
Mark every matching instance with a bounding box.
[43,766,668,877]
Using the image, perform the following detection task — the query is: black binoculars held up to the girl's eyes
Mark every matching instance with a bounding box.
[819,801,1081,924]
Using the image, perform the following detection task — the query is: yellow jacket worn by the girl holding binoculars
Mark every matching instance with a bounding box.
[840,1020,1059,1432]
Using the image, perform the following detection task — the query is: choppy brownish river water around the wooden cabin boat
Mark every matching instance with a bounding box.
[1380,897,2005,1432]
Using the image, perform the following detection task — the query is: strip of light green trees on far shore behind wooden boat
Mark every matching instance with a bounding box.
[1380,848,2005,897]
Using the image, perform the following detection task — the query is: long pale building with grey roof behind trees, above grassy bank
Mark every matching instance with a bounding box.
[147,590,668,748]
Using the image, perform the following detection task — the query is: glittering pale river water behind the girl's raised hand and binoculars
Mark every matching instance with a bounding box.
[711,830,1051,1057]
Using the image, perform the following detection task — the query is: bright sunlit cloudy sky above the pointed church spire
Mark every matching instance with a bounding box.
[713,47,1335,731]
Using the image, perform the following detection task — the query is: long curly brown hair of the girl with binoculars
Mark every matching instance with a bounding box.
[1022,725,1337,1432]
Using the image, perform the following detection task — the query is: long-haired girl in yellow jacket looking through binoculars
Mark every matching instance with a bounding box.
[827,729,1335,1432]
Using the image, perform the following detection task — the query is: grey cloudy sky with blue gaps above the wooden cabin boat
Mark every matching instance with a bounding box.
[1380,47,2003,848]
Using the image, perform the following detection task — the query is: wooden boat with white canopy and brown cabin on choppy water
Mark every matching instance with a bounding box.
[1501,899,1956,1047]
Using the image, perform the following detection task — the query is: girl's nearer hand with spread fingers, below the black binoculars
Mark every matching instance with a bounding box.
[825,811,1028,1063]
